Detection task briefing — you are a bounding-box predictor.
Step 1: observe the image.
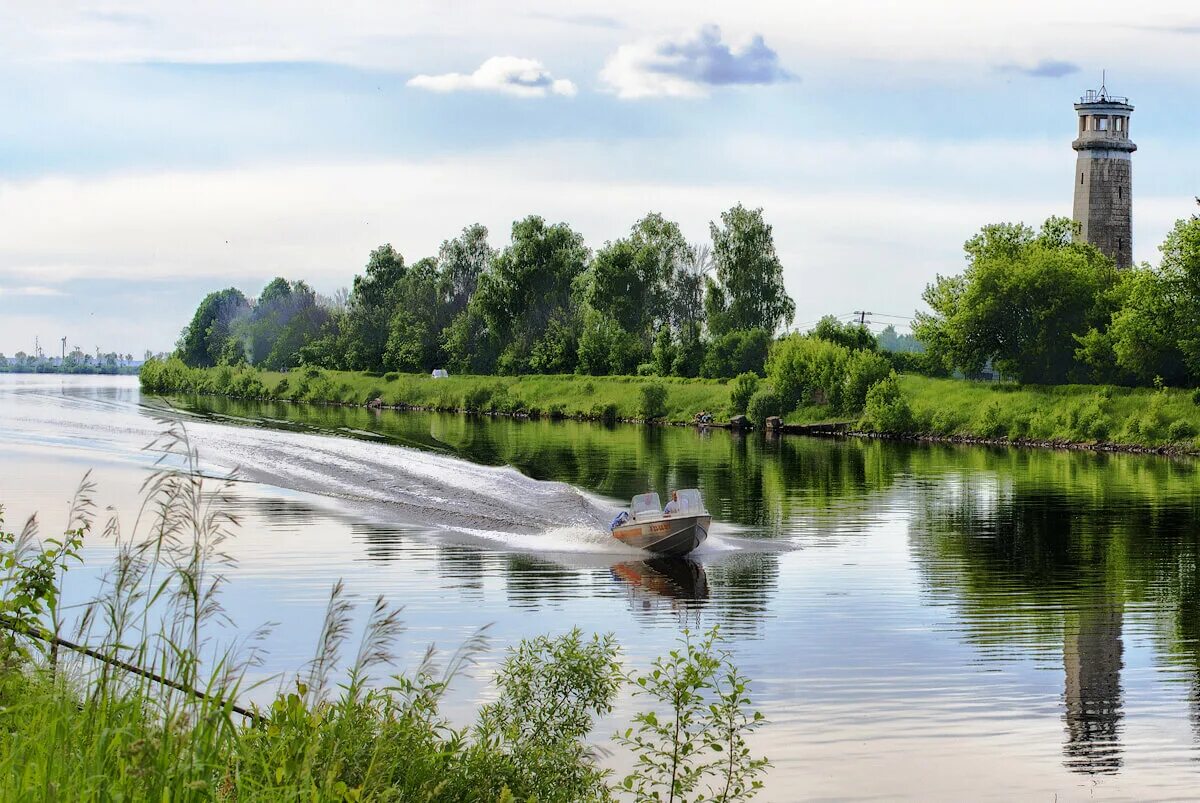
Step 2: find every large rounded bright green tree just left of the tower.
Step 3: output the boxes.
[913,218,1118,383]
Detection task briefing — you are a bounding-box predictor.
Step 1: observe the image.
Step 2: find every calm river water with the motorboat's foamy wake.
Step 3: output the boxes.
[0,374,1200,801]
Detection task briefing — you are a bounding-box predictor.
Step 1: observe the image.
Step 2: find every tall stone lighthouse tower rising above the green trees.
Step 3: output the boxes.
[1072,82,1138,268]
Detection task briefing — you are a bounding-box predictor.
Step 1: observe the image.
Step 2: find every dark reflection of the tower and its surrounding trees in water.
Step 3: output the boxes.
[910,453,1200,774]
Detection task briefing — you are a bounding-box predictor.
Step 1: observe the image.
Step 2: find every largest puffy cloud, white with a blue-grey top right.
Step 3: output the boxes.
[600,25,790,98]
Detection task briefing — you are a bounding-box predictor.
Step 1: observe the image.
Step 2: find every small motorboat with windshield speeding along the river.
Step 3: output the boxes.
[612,489,713,557]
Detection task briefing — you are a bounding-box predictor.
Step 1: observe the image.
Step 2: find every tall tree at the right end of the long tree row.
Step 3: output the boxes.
[707,204,796,335]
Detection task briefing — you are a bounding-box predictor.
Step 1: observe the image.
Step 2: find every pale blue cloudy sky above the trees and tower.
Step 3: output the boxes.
[0,0,1200,355]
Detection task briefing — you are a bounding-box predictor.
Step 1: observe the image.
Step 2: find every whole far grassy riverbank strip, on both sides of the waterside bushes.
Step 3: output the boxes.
[140,360,1200,454]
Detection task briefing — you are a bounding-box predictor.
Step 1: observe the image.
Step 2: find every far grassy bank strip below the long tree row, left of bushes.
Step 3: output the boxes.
[140,360,730,421]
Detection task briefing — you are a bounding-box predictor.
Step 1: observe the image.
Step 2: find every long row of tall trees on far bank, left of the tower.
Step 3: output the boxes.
[176,204,796,377]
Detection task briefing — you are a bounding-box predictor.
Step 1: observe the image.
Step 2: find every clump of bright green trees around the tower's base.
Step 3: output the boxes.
[913,204,1200,386]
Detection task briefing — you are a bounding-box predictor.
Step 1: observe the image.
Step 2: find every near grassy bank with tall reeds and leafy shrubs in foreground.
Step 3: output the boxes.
[0,429,768,803]
